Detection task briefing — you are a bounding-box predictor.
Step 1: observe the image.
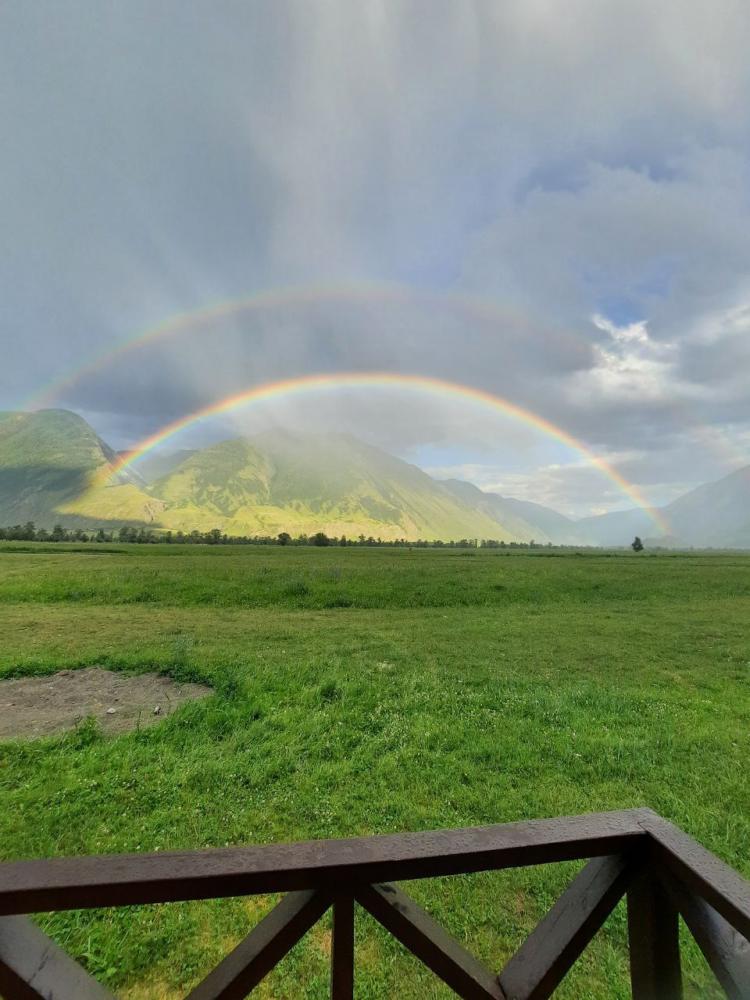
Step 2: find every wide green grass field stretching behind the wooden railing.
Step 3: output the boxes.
[0,544,750,1000]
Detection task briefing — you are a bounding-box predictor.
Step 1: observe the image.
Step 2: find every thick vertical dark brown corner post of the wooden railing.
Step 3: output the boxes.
[628,866,682,1000]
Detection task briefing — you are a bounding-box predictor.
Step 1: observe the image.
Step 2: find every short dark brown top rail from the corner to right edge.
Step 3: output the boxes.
[641,813,750,940]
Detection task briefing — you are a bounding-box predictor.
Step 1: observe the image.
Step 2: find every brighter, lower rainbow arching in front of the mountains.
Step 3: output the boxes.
[102,372,670,534]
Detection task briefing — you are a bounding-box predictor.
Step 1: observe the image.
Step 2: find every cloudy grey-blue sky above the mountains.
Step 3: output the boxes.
[0,0,750,516]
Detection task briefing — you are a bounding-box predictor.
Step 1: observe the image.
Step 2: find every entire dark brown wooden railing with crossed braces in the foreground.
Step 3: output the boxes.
[0,809,750,1000]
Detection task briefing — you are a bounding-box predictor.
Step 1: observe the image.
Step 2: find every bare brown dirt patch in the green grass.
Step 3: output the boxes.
[0,667,212,740]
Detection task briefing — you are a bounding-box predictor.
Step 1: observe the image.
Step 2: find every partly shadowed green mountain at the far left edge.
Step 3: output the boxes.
[0,410,160,527]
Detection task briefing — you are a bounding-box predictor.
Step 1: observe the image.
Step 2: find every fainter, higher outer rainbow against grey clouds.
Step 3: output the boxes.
[20,282,586,410]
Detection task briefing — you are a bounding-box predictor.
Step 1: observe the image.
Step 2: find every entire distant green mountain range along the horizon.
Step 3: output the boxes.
[0,410,750,548]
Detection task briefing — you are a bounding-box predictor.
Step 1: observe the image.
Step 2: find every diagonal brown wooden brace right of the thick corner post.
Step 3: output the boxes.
[659,871,750,1000]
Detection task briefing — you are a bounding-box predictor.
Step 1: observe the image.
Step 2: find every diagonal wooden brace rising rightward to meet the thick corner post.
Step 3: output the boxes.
[498,855,640,1000]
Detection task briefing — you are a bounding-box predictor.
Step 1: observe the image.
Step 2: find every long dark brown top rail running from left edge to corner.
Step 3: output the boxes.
[0,809,652,914]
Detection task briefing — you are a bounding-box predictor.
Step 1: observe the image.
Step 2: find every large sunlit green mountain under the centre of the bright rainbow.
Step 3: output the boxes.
[151,431,519,541]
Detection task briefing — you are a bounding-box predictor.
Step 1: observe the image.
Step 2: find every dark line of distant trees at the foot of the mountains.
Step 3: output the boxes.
[0,521,564,549]
